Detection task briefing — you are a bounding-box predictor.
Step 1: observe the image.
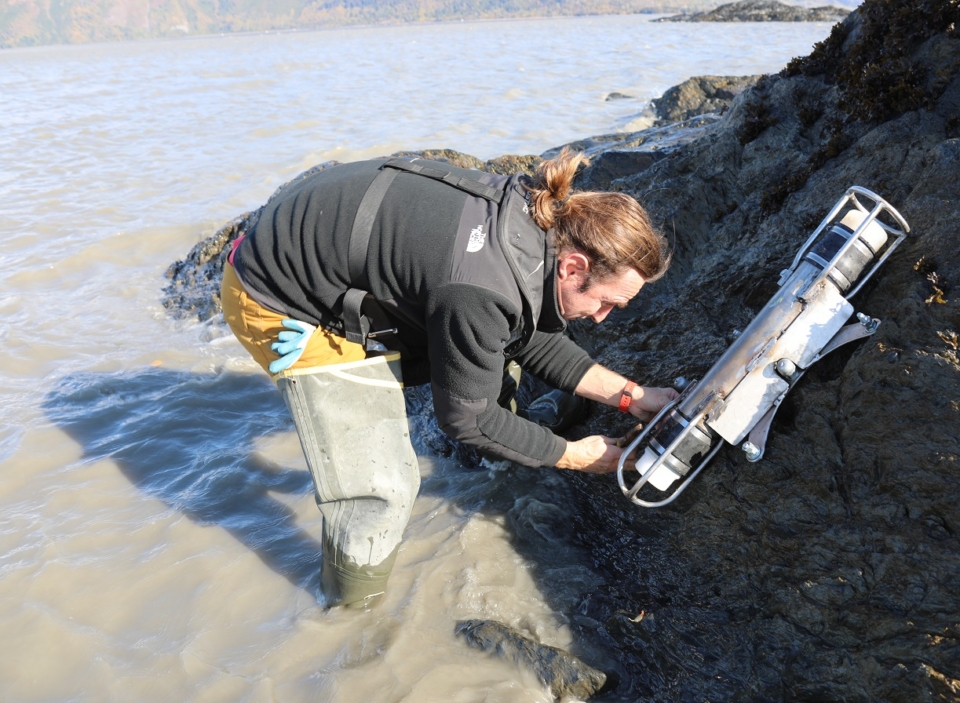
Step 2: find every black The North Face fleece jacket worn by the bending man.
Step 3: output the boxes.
[234,160,594,466]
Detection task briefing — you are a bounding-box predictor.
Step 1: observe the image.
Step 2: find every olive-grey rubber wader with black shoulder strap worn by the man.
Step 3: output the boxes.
[274,160,503,606]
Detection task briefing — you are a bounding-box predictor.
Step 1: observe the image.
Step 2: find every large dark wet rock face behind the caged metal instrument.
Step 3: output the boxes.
[169,0,960,701]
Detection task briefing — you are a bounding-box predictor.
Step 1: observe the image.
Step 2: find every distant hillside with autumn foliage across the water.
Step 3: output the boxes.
[0,0,717,48]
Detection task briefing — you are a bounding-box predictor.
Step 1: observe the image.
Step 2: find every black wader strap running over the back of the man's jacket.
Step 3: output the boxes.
[343,159,504,345]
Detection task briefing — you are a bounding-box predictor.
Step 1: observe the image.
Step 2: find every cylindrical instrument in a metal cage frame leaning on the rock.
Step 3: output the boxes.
[617,186,910,508]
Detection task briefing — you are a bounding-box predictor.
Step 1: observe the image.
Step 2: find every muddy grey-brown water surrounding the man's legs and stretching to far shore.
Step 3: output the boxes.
[0,17,829,703]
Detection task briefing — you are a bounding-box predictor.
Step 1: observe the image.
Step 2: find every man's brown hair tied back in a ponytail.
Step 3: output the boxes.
[527,147,670,281]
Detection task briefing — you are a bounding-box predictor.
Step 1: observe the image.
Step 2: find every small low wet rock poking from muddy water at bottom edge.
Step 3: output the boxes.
[456,620,607,700]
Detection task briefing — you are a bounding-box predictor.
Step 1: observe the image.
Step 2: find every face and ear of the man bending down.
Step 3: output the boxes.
[557,252,644,322]
